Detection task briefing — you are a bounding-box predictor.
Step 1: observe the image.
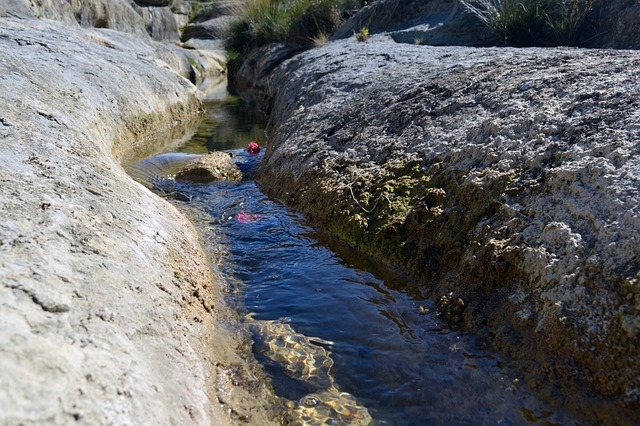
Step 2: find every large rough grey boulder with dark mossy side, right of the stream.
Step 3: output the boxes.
[258,35,640,423]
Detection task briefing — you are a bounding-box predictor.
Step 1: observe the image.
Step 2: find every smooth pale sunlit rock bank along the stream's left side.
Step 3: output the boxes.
[0,18,274,425]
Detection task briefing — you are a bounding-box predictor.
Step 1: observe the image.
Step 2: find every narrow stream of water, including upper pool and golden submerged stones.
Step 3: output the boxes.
[130,97,576,425]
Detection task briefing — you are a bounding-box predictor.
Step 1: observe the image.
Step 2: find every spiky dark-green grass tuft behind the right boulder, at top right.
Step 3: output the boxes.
[459,0,599,46]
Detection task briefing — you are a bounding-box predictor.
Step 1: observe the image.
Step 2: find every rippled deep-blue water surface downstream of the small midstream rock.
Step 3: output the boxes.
[176,175,572,425]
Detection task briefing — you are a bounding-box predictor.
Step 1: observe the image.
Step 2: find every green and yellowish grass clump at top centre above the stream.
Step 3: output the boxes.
[225,0,364,56]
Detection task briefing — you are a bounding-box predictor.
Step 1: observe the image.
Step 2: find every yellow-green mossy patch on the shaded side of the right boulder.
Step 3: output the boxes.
[320,160,521,292]
